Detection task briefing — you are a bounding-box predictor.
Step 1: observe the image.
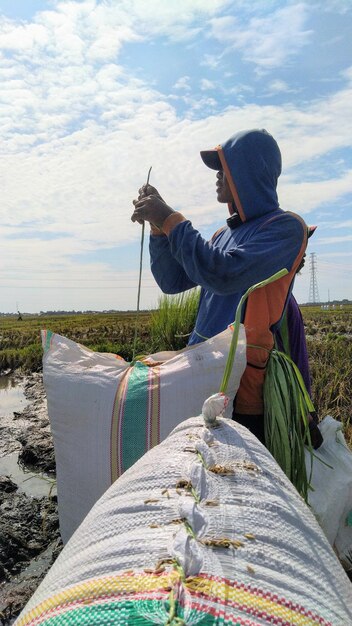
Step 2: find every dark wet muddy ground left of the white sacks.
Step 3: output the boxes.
[0,373,62,626]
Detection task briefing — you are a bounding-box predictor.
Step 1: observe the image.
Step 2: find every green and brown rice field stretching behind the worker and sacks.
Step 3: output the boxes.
[0,299,352,443]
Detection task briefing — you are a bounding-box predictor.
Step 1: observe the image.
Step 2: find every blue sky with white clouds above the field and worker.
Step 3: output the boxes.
[0,0,352,313]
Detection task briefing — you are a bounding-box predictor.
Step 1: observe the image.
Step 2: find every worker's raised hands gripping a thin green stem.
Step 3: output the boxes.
[131,185,174,228]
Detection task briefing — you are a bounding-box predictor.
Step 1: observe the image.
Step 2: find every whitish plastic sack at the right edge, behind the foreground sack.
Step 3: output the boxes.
[306,415,352,569]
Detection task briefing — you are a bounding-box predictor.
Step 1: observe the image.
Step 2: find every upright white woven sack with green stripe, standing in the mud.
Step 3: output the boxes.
[42,326,246,542]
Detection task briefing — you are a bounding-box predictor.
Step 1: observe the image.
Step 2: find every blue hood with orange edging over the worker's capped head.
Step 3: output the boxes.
[201,129,281,222]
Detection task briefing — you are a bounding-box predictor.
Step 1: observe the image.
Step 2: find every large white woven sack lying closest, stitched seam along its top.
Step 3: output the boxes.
[16,400,352,626]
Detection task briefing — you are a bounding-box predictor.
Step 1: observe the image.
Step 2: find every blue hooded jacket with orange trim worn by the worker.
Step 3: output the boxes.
[150,129,307,345]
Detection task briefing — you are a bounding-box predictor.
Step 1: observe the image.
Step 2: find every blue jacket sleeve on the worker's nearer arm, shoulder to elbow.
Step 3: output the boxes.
[168,213,305,295]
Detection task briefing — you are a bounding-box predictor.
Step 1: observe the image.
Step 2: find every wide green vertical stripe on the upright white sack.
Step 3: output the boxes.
[121,361,149,471]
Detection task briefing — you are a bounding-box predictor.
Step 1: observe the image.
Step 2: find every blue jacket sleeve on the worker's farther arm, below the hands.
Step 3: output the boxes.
[149,235,198,294]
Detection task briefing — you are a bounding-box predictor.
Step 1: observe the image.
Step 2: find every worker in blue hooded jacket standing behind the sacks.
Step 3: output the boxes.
[131,129,320,442]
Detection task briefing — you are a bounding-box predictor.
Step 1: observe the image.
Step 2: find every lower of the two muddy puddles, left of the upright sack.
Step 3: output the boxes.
[0,452,57,498]
